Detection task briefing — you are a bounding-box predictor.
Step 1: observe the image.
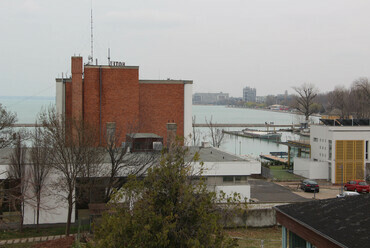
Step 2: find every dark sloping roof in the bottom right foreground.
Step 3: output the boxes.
[275,194,370,247]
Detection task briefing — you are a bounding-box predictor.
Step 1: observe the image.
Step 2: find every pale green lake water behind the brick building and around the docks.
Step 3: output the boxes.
[0,96,317,157]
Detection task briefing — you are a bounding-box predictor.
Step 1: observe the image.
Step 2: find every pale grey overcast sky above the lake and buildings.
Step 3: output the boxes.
[0,0,370,96]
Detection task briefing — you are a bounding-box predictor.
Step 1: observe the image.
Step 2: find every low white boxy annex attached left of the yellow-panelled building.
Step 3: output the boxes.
[293,158,329,179]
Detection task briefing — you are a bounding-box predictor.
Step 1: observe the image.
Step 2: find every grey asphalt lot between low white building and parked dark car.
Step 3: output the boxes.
[248,179,310,203]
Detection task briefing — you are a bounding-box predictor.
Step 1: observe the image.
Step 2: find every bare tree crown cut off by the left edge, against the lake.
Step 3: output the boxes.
[0,104,17,149]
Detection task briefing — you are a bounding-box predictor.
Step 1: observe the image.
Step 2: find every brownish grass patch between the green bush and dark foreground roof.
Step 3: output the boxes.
[226,227,281,248]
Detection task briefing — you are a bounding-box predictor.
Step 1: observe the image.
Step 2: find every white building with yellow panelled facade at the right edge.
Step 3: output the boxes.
[294,119,370,183]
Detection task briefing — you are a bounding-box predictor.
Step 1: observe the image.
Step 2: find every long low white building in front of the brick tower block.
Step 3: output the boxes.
[0,146,261,225]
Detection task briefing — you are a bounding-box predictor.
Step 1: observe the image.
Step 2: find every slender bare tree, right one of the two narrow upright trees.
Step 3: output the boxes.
[30,126,51,232]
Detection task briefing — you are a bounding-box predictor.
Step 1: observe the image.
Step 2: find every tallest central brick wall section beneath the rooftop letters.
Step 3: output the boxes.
[84,66,139,143]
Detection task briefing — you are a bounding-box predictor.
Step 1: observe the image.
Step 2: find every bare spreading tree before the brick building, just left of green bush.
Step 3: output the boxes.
[104,123,159,202]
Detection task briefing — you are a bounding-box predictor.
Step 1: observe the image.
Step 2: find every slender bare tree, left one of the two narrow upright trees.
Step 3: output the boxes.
[8,131,29,231]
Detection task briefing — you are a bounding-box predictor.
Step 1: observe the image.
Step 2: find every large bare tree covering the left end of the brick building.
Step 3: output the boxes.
[39,108,103,236]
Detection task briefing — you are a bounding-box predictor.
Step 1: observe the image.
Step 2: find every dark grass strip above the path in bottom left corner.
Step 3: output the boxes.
[0,225,89,240]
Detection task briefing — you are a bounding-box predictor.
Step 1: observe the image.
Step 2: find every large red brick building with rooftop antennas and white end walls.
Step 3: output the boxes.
[56,57,193,145]
